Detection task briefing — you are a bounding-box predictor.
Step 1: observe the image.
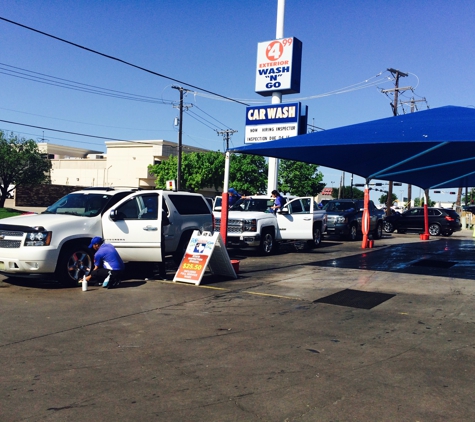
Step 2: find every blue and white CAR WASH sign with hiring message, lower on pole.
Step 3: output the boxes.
[244,103,301,144]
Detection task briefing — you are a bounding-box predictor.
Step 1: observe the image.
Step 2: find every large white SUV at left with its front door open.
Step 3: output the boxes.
[0,188,213,284]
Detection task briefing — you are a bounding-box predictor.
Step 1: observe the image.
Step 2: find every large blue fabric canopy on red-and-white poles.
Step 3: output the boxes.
[230,106,475,189]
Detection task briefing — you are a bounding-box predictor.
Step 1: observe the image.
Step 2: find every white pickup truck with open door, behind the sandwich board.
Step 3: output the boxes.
[214,195,327,255]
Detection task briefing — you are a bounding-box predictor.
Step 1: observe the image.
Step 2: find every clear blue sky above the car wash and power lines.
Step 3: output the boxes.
[0,0,475,200]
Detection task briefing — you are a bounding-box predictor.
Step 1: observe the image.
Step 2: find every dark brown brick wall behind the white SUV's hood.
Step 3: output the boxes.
[15,185,84,207]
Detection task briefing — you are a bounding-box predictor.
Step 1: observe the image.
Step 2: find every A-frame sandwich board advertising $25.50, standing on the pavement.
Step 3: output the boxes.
[173,230,237,286]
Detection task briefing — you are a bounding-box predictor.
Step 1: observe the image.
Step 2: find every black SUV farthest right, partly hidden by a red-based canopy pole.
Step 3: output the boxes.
[384,207,462,236]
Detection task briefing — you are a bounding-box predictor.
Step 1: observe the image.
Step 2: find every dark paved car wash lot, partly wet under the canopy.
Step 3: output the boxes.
[0,230,475,422]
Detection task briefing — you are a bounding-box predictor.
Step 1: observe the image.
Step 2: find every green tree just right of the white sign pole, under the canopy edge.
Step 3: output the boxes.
[278,160,325,196]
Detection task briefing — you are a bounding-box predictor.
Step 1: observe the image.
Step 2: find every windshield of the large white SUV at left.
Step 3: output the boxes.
[44,193,111,217]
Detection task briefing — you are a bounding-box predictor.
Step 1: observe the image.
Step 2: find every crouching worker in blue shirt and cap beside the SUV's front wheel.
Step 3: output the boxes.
[86,236,125,289]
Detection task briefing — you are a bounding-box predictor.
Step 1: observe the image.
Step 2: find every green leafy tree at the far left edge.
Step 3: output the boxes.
[0,130,51,208]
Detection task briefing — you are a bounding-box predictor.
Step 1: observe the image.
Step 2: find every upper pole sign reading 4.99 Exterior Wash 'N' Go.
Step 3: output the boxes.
[256,38,302,97]
